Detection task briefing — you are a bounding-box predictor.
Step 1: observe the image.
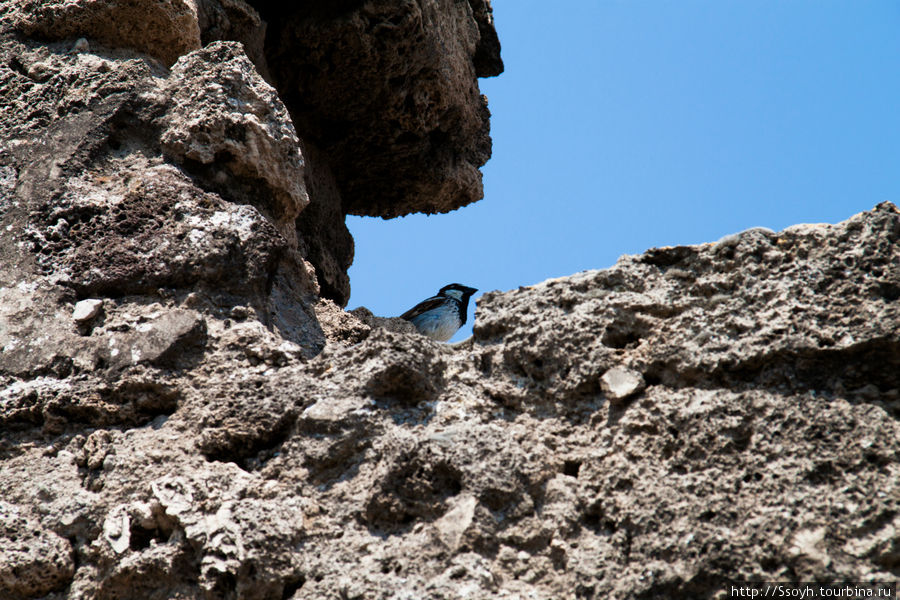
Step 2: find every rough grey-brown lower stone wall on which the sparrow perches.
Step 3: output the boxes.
[0,198,900,599]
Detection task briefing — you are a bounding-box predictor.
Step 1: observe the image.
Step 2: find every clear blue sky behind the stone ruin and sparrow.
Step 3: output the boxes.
[347,0,900,341]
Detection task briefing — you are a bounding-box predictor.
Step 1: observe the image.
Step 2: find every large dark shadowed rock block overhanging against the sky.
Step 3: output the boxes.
[260,0,503,218]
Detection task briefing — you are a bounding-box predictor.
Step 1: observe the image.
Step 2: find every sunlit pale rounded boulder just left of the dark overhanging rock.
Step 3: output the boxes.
[160,42,312,244]
